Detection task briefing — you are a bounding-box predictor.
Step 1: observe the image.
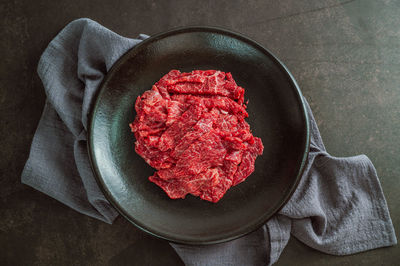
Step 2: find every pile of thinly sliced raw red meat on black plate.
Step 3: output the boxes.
[130,70,264,202]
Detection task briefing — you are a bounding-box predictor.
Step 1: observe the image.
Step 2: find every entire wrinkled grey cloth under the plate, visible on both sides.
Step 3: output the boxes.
[22,19,397,265]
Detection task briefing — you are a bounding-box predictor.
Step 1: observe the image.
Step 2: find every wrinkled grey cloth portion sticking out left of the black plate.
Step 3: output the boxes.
[22,19,146,223]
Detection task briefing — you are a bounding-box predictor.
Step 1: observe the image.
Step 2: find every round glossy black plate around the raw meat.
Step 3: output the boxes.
[88,27,309,244]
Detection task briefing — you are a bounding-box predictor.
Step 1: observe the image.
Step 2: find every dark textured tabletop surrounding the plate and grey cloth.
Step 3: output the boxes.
[0,0,400,265]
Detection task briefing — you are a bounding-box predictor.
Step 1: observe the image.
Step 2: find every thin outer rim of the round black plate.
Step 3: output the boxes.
[87,26,310,245]
